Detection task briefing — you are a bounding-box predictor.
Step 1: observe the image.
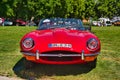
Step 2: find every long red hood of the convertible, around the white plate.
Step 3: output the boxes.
[22,28,99,53]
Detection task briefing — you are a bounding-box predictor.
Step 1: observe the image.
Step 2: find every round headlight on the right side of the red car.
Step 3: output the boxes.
[87,38,98,51]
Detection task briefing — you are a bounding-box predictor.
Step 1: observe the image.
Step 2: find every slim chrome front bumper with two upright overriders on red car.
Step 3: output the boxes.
[21,50,100,60]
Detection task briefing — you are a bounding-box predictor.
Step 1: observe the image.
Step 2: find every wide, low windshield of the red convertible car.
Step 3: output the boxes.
[38,18,84,30]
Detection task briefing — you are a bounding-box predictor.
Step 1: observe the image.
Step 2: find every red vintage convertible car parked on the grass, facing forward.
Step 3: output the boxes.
[20,18,100,67]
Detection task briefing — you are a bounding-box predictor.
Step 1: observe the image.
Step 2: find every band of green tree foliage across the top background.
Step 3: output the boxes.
[0,0,120,20]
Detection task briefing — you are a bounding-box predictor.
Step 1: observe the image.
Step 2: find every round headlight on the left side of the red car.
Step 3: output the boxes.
[22,38,34,49]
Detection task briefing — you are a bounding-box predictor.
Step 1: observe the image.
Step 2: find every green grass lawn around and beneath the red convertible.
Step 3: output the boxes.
[0,26,120,80]
